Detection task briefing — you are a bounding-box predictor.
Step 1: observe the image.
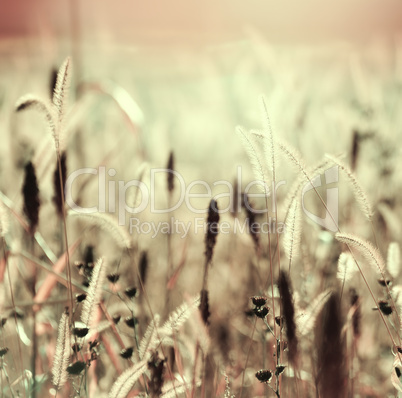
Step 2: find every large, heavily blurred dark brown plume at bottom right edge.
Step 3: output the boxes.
[316,293,347,398]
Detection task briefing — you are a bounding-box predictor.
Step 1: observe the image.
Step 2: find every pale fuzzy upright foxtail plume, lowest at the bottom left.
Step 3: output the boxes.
[52,309,70,390]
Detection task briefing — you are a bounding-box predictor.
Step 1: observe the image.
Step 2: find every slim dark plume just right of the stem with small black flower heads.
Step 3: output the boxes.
[278,271,298,364]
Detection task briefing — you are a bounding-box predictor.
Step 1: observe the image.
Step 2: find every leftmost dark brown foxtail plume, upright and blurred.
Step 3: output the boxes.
[22,162,40,234]
